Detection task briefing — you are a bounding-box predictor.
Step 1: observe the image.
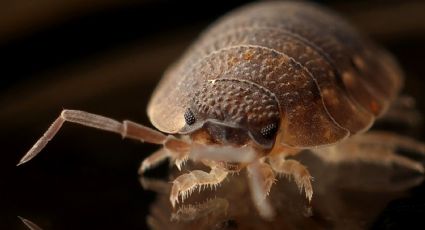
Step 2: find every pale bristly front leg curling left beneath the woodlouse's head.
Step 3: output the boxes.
[170,167,228,207]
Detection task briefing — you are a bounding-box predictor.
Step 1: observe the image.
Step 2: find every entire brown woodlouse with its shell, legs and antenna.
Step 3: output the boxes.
[20,2,423,217]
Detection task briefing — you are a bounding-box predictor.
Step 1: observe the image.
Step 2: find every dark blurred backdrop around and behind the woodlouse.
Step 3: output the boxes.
[0,0,425,229]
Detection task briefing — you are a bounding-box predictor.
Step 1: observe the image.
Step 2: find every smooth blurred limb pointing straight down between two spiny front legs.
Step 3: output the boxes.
[247,161,275,219]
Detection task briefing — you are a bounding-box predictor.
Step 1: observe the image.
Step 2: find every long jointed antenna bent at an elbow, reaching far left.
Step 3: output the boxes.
[18,109,184,165]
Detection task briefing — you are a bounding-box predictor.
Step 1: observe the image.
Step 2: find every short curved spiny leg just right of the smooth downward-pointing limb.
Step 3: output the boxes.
[269,154,313,201]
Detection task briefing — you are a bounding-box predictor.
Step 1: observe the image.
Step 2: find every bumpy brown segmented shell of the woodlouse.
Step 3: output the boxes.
[148,2,402,148]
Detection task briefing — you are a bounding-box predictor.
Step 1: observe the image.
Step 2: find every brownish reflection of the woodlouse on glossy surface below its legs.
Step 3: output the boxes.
[147,151,423,230]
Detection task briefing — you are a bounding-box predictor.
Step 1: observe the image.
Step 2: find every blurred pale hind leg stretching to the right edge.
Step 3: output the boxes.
[312,131,425,173]
